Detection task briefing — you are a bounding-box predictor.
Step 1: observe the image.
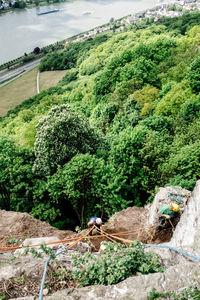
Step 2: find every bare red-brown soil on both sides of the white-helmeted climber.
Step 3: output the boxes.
[0,207,172,250]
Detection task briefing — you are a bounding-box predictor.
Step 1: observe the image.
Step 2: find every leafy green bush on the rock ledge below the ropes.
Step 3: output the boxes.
[72,241,163,286]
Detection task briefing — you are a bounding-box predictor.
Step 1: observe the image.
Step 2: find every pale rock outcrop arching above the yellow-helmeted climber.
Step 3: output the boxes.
[148,186,191,225]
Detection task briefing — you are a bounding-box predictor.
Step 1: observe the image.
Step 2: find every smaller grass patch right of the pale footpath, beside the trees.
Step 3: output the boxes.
[40,70,66,91]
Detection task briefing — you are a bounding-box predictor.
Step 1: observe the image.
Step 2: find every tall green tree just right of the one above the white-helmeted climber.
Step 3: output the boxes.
[108,126,148,206]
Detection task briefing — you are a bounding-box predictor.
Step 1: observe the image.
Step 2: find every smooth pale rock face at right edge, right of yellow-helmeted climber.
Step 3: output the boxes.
[170,180,200,250]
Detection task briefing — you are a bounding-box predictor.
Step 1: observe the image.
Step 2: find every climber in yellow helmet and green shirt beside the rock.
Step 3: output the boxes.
[157,203,182,231]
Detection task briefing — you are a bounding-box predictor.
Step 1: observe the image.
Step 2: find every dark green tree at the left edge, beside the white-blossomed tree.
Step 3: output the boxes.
[0,136,36,211]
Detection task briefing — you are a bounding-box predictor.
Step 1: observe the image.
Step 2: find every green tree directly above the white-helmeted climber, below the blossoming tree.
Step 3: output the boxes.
[48,153,108,228]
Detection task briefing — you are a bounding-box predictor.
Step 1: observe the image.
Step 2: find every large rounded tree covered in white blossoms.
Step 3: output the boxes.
[33,104,104,175]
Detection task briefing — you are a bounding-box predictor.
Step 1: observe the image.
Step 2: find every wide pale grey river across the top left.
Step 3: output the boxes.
[0,0,169,64]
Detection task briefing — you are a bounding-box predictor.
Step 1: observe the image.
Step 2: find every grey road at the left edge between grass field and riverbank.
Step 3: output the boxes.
[0,58,41,86]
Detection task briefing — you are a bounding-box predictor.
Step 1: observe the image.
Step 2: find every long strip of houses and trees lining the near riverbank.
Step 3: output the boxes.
[0,0,200,70]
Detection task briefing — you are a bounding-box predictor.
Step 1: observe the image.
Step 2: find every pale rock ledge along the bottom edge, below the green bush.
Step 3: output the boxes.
[41,263,200,300]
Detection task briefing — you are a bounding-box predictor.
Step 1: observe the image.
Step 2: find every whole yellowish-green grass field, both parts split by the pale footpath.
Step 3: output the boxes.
[0,68,66,117]
